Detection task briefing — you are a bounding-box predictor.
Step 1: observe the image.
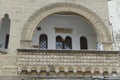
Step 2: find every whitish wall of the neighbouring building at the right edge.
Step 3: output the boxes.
[108,0,120,50]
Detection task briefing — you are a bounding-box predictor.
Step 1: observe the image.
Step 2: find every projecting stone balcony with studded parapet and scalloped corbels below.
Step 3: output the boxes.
[17,49,120,76]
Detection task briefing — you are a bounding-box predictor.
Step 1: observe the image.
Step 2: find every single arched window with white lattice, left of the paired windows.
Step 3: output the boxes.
[39,34,48,49]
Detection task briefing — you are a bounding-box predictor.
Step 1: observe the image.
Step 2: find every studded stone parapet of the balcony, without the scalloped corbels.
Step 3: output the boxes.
[17,50,120,76]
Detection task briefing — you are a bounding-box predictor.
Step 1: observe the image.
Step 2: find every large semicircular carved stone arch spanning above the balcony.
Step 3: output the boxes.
[21,2,112,50]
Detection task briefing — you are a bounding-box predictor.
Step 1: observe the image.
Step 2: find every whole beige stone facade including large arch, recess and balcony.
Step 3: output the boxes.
[0,0,120,77]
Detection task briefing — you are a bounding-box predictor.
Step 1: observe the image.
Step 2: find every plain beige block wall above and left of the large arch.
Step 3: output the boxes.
[0,0,111,76]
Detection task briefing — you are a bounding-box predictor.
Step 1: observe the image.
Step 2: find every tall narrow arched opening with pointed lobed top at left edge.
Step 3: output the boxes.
[0,13,10,49]
